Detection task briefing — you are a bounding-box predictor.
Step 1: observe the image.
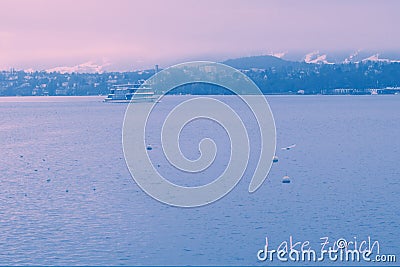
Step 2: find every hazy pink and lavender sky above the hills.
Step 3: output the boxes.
[0,0,400,69]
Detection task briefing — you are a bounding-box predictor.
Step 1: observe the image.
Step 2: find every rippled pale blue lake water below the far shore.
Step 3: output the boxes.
[0,96,400,265]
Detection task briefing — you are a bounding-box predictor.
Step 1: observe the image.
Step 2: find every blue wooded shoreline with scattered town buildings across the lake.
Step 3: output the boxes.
[0,56,400,96]
